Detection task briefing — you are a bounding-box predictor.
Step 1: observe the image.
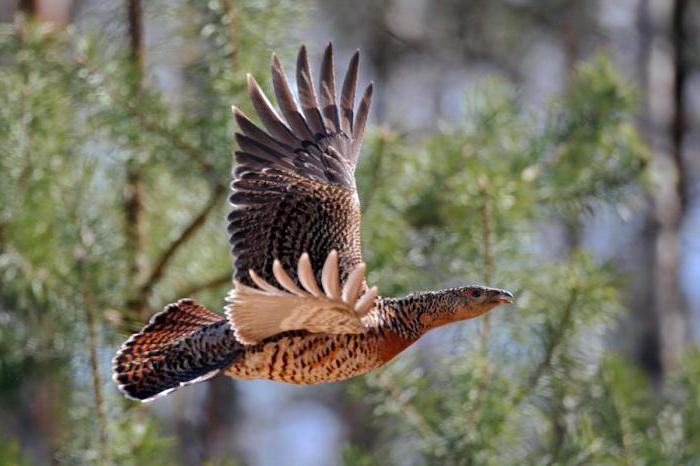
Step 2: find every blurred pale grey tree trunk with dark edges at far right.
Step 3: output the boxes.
[640,0,689,375]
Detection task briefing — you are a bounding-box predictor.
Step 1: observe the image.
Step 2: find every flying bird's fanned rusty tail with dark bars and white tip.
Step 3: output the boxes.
[112,299,241,401]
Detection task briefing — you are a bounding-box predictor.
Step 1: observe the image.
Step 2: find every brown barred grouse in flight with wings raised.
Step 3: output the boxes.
[112,43,513,401]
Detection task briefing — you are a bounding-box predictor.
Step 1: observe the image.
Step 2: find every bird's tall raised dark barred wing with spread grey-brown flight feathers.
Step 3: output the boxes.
[228,44,372,289]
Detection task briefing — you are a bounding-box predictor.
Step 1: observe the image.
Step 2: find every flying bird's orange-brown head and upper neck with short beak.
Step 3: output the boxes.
[419,285,513,329]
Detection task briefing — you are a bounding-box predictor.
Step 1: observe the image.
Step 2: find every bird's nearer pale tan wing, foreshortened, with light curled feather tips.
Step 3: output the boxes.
[226,250,377,344]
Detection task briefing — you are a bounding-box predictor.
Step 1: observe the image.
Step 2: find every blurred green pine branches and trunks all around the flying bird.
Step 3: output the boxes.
[0,0,700,465]
